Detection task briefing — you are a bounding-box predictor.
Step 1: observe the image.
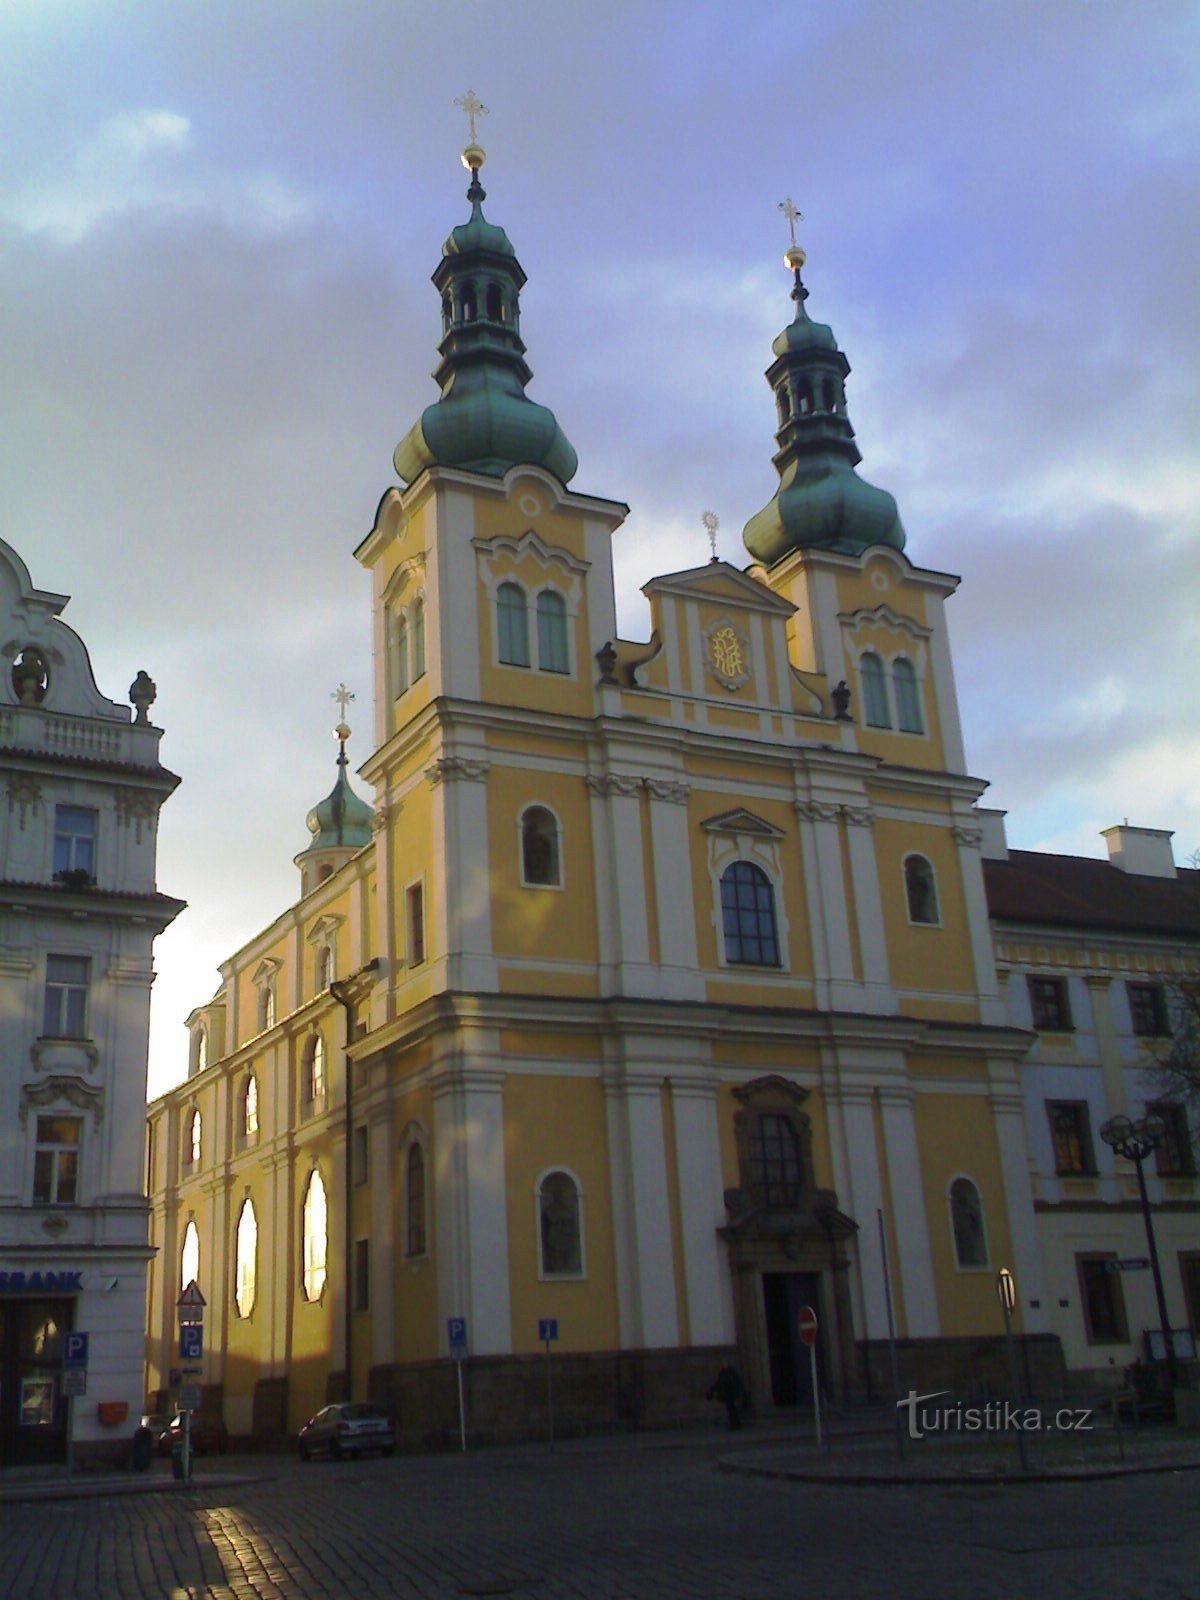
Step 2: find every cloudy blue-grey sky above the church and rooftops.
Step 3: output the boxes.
[0,0,1200,1093]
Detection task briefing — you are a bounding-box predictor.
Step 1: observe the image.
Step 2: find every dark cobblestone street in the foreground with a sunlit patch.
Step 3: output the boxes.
[0,1437,1200,1600]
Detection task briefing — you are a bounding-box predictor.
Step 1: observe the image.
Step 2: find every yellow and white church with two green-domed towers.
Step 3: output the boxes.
[147,139,1177,1443]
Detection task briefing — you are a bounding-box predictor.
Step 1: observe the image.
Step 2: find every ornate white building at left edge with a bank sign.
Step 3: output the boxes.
[0,541,182,1466]
